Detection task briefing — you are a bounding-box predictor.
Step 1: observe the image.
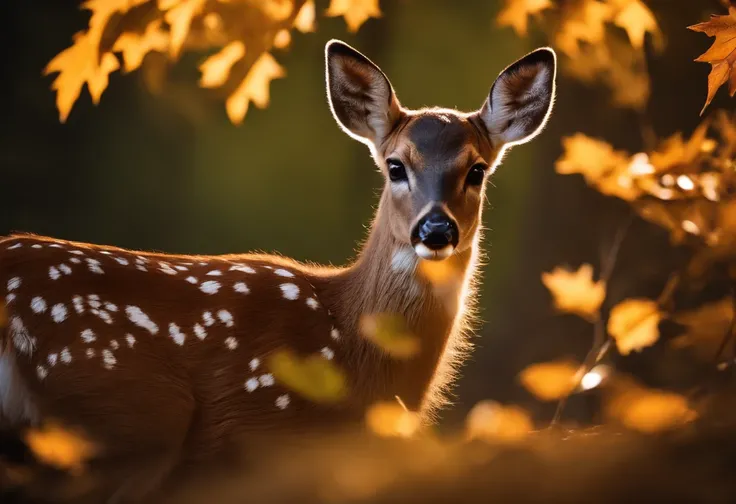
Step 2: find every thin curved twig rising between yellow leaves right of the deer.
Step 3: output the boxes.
[550,217,634,427]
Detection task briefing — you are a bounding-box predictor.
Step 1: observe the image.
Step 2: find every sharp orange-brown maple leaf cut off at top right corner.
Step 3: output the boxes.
[688,7,736,115]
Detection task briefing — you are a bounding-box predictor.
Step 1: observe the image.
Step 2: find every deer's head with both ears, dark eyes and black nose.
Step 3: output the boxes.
[326,40,556,260]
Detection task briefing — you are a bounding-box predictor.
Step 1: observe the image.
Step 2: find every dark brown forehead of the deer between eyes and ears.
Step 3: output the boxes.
[386,110,489,173]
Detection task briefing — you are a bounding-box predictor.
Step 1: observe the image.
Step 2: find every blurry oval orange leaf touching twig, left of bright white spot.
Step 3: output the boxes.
[519,361,581,401]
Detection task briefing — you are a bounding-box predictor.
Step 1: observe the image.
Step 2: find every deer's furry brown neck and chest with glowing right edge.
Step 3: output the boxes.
[320,193,479,412]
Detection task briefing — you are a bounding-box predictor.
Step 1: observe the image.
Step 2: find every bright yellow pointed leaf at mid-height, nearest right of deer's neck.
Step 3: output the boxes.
[542,264,606,319]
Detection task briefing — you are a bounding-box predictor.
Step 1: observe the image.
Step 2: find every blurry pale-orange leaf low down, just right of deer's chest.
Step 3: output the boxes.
[465,401,534,443]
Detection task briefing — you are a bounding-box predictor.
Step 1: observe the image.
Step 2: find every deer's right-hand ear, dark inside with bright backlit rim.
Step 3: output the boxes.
[479,48,557,146]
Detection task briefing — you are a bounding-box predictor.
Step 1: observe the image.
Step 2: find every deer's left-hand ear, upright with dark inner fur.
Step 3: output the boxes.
[325,40,401,146]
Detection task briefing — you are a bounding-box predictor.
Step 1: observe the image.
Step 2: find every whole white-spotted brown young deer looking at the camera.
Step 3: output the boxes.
[0,40,556,502]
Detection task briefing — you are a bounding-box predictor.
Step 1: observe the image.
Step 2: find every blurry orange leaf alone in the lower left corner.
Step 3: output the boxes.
[25,424,95,470]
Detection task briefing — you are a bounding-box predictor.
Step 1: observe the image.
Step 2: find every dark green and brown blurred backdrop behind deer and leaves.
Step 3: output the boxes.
[0,0,732,425]
